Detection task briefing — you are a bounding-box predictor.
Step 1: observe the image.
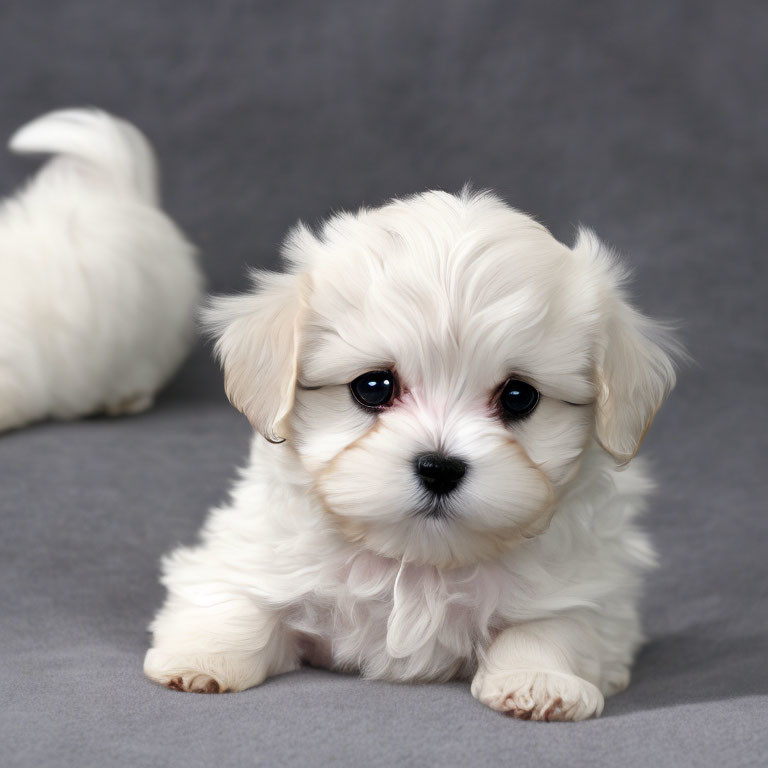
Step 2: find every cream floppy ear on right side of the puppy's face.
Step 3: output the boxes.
[573,229,681,466]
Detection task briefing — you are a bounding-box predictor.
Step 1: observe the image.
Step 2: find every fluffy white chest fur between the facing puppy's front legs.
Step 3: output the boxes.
[286,556,495,680]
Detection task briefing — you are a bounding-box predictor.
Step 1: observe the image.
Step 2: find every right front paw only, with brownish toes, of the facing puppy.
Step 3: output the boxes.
[472,667,604,720]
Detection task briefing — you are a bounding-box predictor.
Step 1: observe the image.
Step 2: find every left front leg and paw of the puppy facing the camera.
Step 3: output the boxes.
[144,569,299,693]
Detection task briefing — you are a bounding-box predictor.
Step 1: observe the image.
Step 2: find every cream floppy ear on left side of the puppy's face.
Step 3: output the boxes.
[203,272,307,443]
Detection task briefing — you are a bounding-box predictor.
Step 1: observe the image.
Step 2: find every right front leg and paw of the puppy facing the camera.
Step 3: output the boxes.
[472,618,603,720]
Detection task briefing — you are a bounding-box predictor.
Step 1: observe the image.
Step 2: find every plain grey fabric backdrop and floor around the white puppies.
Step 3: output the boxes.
[0,0,768,767]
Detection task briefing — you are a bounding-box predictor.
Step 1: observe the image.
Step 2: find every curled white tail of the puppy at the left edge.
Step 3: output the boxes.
[8,109,159,204]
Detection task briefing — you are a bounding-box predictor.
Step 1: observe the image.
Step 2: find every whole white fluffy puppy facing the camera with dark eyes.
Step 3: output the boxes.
[145,192,674,720]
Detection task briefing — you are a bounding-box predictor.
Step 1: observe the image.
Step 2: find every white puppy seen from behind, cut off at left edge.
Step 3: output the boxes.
[0,109,202,431]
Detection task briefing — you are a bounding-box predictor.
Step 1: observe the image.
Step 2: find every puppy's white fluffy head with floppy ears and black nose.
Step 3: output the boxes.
[208,192,674,567]
